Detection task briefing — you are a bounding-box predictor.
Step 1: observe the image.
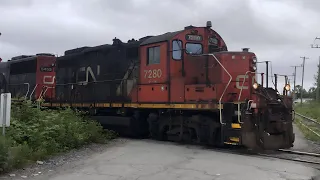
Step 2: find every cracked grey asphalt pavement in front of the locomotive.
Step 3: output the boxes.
[17,140,319,180]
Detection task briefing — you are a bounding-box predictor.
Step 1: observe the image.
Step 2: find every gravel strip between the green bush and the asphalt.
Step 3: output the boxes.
[0,139,127,180]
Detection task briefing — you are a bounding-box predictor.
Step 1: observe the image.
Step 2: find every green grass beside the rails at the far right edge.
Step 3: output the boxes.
[295,101,320,143]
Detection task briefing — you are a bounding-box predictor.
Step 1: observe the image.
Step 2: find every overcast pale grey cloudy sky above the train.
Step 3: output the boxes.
[0,0,320,88]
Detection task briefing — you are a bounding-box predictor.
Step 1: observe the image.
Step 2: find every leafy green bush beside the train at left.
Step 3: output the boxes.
[0,103,115,173]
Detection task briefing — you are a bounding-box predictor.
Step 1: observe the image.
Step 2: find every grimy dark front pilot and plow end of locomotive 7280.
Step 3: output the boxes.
[242,88,295,150]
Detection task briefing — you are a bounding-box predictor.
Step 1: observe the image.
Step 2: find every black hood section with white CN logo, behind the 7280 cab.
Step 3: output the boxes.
[55,38,142,103]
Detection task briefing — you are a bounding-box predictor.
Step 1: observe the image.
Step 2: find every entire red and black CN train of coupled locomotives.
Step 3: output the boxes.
[0,21,294,150]
